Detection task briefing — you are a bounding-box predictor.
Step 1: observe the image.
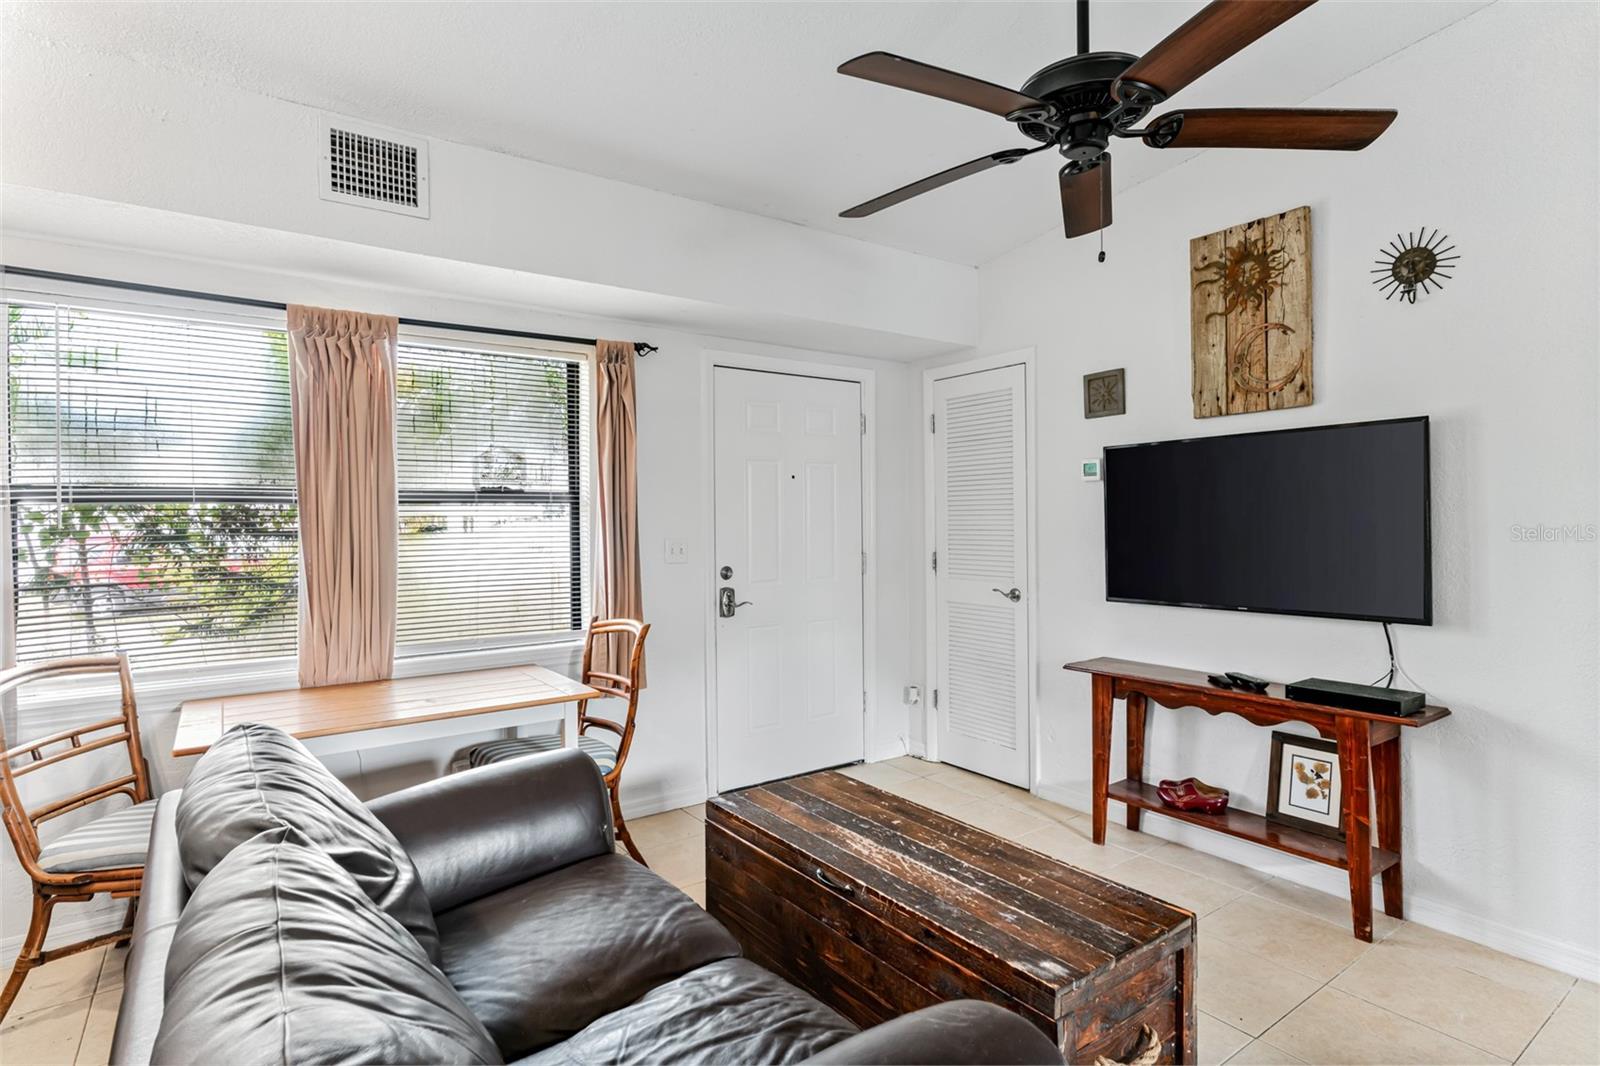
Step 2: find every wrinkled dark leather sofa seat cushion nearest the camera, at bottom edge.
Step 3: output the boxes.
[518,959,856,1066]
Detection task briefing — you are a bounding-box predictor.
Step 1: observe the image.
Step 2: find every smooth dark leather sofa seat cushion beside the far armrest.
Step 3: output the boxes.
[438,855,739,1058]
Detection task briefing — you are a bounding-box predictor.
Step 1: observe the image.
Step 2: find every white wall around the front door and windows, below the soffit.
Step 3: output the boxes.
[0,235,918,951]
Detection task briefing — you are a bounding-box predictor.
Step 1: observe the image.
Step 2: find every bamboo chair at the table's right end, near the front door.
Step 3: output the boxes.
[467,618,650,866]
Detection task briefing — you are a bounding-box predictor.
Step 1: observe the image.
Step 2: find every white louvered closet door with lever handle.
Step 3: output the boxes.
[933,367,1030,787]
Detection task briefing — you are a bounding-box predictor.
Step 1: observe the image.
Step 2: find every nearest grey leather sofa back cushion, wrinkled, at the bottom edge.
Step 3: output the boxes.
[150,826,501,1063]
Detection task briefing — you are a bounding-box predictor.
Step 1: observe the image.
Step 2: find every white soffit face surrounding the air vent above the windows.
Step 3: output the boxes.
[0,30,978,355]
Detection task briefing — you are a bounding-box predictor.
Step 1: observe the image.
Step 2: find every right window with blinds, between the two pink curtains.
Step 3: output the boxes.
[395,339,587,656]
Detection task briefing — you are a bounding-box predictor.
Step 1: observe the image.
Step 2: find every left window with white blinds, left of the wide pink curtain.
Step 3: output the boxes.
[5,303,298,667]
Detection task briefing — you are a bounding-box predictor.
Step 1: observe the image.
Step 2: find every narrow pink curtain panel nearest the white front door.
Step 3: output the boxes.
[592,341,645,687]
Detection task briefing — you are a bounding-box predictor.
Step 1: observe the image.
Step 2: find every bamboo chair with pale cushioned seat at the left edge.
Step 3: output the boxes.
[0,655,155,1020]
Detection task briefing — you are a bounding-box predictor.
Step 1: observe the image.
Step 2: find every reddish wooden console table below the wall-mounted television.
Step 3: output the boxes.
[1066,659,1450,941]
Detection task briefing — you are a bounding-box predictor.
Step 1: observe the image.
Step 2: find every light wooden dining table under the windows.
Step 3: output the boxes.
[173,666,600,757]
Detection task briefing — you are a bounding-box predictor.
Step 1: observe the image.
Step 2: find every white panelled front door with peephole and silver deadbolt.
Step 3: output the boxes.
[712,367,866,791]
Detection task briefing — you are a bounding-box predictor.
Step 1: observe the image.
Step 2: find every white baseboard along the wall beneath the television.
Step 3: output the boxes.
[1035,784,1600,981]
